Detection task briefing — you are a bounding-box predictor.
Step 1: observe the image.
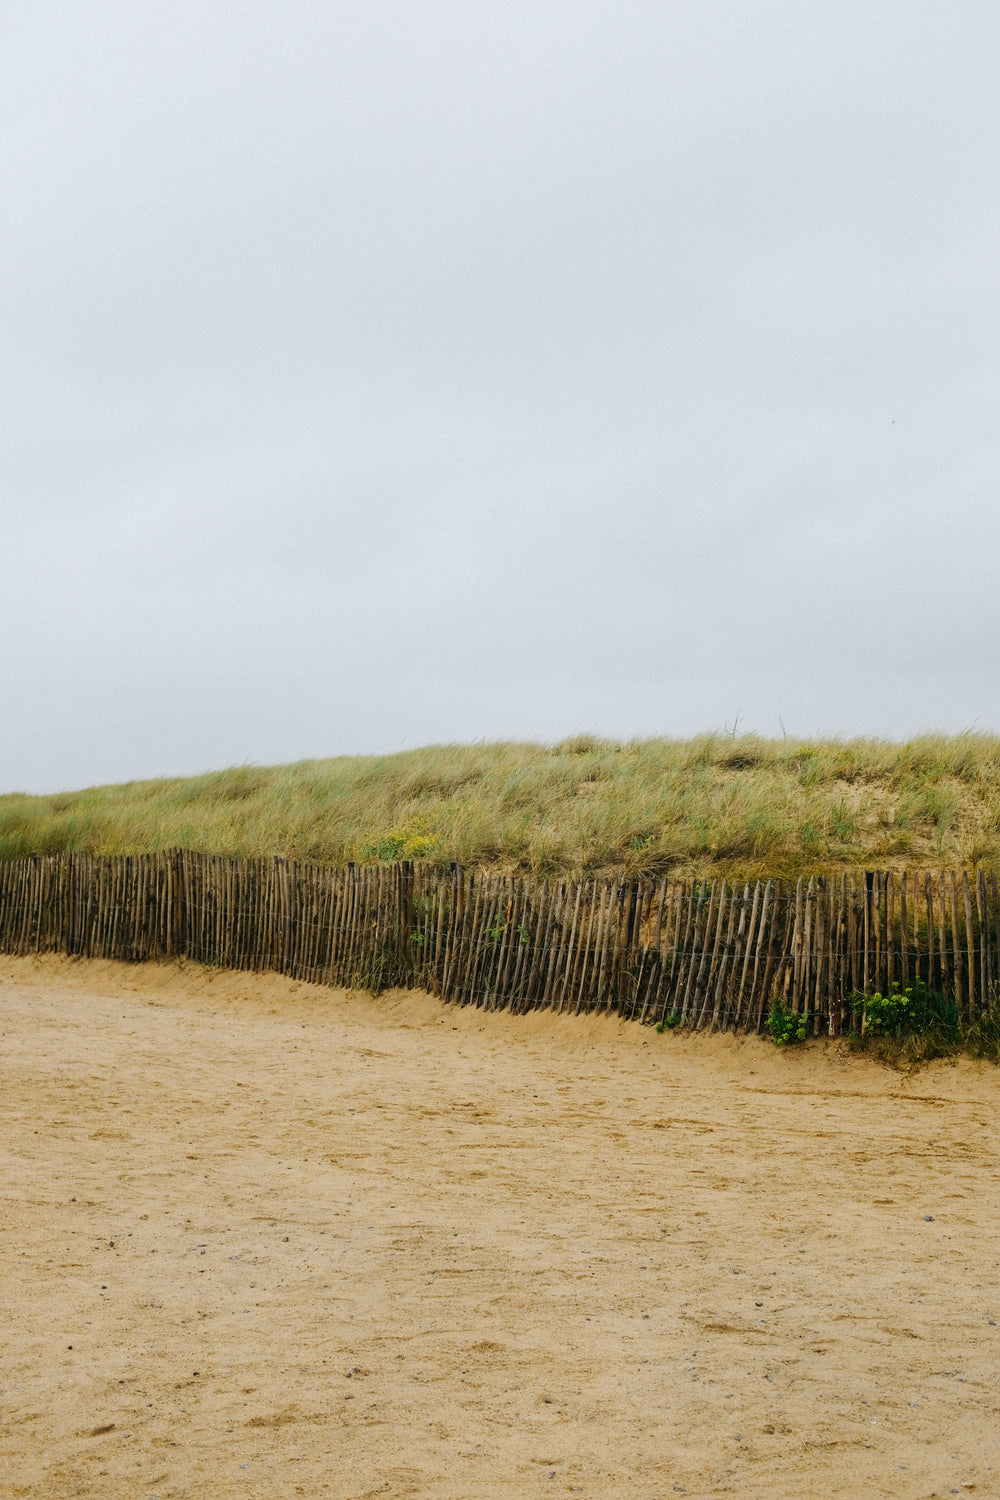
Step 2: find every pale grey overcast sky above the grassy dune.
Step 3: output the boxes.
[0,0,1000,791]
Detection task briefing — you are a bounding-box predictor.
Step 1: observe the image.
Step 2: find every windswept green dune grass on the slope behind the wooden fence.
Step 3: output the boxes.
[0,735,1000,876]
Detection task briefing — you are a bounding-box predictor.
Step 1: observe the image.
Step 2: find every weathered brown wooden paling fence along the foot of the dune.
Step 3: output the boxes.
[0,851,1000,1037]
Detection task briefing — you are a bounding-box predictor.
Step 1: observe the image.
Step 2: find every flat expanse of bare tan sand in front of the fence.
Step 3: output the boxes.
[0,959,1000,1500]
